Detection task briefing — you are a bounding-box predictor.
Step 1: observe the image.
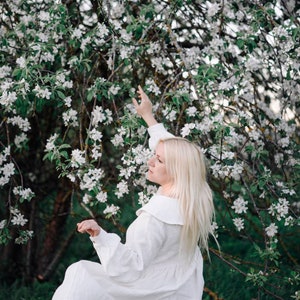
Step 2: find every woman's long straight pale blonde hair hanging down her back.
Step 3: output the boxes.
[161,137,214,256]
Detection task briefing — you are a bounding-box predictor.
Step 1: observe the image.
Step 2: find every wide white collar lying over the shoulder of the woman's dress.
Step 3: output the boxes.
[136,194,184,225]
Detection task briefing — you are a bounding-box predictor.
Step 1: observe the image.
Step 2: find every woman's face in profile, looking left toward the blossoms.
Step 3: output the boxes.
[147,142,173,188]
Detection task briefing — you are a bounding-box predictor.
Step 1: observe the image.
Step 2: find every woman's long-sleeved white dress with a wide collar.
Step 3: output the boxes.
[52,124,204,300]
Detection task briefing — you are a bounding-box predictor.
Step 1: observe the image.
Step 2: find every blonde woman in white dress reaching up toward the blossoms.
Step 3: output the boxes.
[53,86,214,300]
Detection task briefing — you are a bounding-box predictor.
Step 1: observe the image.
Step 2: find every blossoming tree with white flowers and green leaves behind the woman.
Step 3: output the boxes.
[0,0,300,299]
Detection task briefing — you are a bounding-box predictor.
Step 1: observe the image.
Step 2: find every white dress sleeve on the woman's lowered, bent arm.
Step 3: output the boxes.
[90,212,165,282]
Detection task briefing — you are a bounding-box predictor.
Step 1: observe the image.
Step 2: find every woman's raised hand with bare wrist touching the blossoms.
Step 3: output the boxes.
[132,85,157,126]
